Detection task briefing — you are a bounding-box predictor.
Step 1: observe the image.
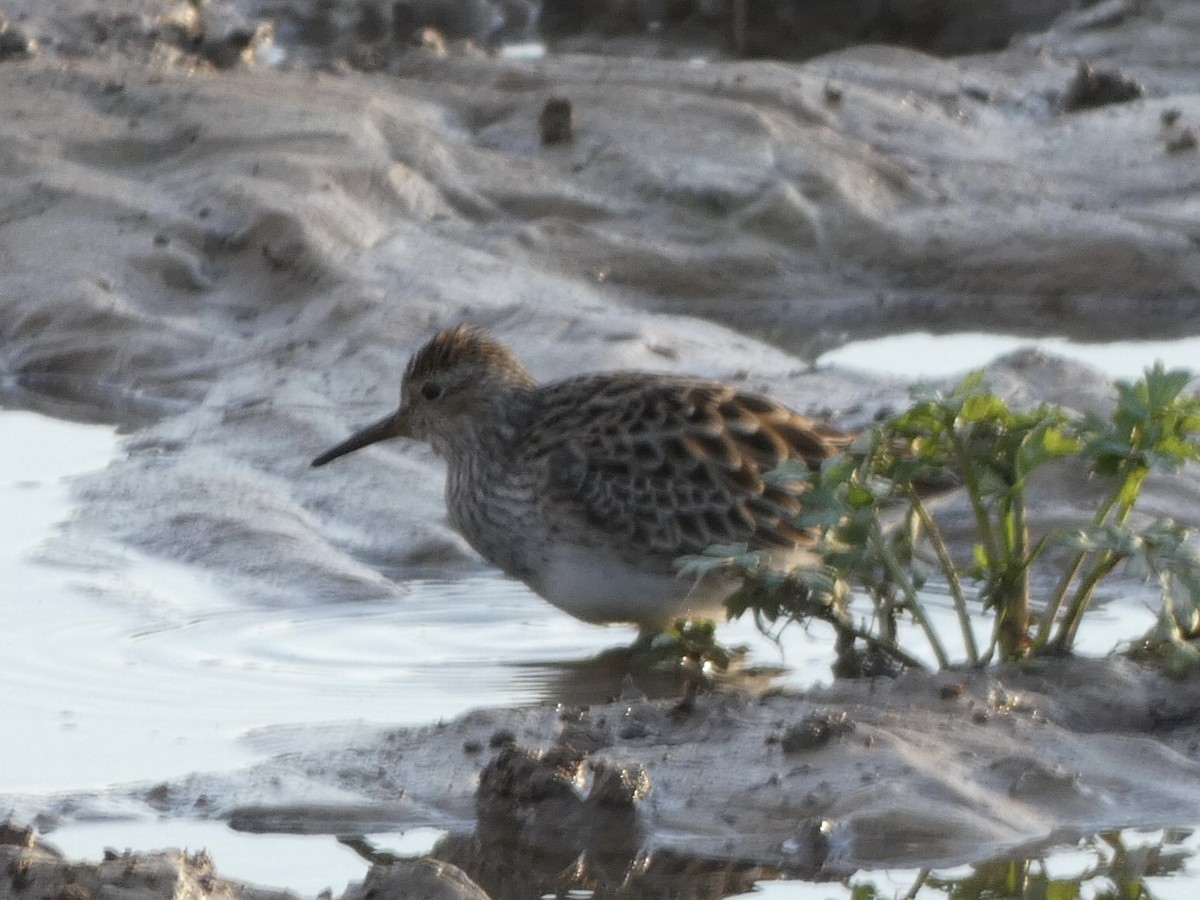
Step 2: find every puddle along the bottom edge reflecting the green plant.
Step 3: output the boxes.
[342,828,1200,900]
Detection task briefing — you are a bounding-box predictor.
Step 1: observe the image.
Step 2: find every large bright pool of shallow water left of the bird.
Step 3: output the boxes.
[0,412,632,792]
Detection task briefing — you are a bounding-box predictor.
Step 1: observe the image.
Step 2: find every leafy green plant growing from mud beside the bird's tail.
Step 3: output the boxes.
[683,365,1200,670]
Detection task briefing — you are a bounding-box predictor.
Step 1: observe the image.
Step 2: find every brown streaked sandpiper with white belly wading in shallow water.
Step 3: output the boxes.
[312,324,854,635]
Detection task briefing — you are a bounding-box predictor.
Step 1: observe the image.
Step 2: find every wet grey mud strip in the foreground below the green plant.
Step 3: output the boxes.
[16,659,1200,896]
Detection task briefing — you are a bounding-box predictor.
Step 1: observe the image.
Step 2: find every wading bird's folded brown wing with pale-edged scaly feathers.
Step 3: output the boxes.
[526,373,852,557]
